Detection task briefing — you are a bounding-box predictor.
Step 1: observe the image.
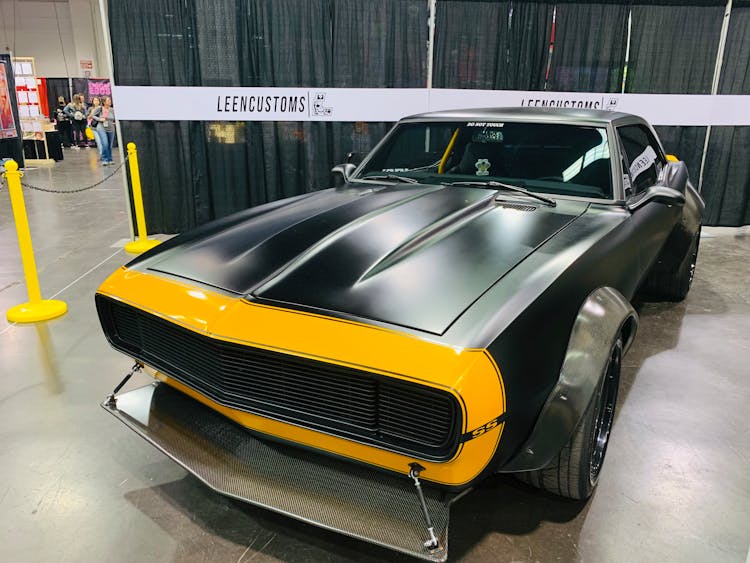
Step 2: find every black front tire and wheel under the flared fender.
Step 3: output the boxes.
[516,338,622,500]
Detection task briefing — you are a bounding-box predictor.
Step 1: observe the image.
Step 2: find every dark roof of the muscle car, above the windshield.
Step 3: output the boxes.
[402,107,633,124]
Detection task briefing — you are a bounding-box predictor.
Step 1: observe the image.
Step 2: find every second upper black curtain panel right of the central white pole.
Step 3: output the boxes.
[547,2,629,92]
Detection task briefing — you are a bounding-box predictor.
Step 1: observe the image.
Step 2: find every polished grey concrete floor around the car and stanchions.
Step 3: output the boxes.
[0,150,750,563]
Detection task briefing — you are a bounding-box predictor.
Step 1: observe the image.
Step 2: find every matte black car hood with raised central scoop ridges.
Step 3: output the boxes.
[141,185,588,334]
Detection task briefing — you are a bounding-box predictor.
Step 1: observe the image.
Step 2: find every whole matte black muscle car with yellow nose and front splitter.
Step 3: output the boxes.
[96,108,703,560]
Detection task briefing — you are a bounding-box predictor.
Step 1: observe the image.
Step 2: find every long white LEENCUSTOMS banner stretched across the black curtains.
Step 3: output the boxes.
[112,86,750,125]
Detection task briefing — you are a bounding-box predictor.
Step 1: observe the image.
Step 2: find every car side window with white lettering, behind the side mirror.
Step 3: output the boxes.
[617,125,665,194]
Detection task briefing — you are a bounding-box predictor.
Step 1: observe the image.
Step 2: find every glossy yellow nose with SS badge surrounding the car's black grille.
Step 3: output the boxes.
[99,268,506,487]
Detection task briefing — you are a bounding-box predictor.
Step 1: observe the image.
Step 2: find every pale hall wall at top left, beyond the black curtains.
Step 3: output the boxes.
[0,0,107,78]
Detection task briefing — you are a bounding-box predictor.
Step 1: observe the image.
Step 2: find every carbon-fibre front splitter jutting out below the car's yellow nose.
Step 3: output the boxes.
[102,383,456,561]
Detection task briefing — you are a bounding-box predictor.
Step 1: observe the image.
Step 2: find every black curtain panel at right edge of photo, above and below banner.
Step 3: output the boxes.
[703,2,750,226]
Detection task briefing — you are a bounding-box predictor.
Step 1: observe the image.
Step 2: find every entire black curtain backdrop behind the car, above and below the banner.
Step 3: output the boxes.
[109,0,750,232]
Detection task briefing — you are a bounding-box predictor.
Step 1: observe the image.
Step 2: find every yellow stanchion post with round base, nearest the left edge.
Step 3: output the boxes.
[3,160,68,323]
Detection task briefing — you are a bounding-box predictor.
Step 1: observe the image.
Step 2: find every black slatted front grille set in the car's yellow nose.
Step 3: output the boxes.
[96,295,461,460]
